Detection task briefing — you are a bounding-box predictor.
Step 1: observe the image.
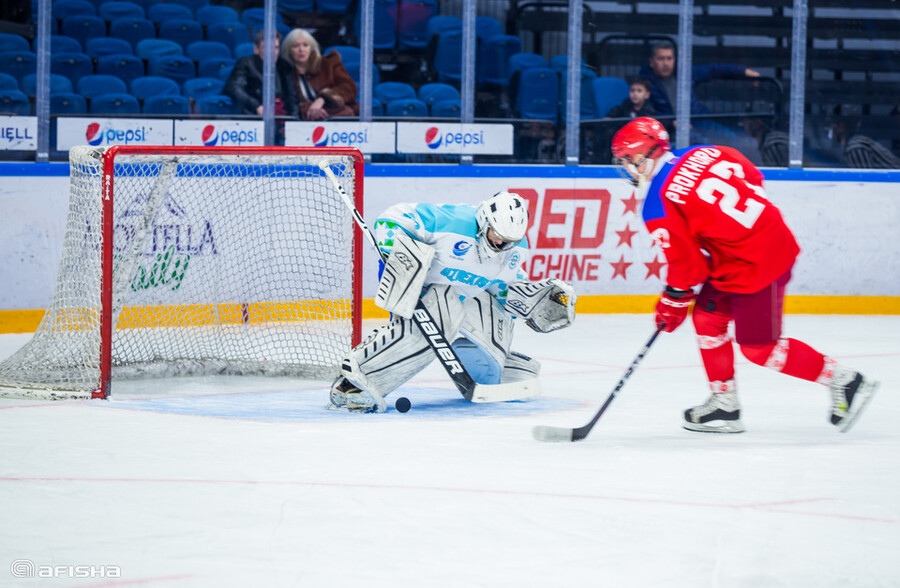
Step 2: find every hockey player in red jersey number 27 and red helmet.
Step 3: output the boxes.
[612,117,878,433]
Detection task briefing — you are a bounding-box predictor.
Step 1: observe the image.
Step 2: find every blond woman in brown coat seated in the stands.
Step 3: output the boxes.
[281,29,359,120]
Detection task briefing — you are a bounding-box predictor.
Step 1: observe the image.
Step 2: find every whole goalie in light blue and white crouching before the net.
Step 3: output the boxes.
[328,192,576,412]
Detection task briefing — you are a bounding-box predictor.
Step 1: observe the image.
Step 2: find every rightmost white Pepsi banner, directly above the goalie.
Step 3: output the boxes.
[397,122,513,155]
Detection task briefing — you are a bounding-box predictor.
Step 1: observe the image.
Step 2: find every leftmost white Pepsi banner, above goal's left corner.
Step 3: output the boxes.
[56,117,172,151]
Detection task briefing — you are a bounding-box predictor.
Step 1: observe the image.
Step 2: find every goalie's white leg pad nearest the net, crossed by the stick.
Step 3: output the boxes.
[341,286,463,402]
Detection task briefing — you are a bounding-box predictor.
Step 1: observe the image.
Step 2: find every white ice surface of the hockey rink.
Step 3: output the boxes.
[0,315,900,588]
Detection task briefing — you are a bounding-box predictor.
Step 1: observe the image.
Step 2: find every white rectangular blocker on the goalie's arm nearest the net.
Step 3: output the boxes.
[375,231,435,319]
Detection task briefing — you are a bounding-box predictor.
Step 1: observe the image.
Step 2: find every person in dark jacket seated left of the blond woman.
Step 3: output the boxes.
[223,31,299,118]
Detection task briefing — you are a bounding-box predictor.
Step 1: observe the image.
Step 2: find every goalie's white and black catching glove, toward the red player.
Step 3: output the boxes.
[506,278,578,333]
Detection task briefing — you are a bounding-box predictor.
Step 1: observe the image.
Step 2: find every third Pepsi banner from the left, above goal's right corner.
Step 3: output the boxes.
[284,122,397,153]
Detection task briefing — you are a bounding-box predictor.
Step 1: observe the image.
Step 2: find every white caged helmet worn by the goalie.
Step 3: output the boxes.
[475,191,528,259]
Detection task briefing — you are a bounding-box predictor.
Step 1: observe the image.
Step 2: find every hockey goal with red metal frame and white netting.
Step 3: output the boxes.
[0,146,363,399]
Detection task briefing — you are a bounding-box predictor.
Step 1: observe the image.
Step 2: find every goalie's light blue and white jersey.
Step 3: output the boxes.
[374,202,528,302]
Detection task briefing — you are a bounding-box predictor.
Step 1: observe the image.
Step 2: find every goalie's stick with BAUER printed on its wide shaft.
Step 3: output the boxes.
[319,159,540,402]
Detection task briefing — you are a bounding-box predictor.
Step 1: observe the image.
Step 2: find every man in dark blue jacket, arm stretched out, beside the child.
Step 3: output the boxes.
[638,41,759,115]
